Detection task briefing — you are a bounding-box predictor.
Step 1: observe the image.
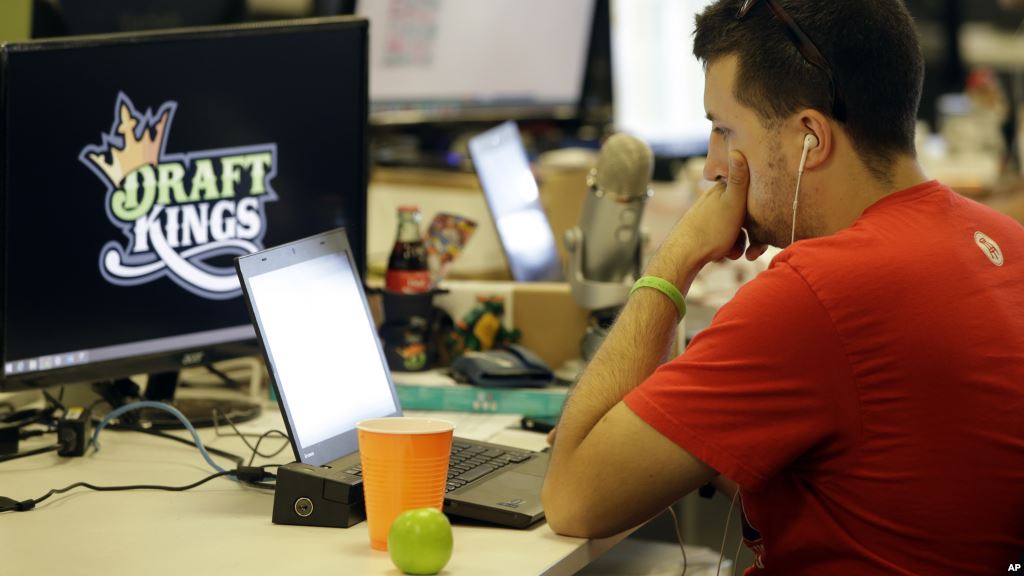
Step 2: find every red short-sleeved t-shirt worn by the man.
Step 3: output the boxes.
[626,181,1024,575]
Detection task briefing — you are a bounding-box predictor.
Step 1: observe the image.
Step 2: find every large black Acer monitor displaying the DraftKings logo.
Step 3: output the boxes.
[0,17,369,409]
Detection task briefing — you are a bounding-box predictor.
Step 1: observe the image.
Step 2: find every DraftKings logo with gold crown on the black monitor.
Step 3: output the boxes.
[79,92,278,299]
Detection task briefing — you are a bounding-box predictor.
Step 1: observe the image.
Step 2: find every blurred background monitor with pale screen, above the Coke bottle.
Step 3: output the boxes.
[356,0,594,124]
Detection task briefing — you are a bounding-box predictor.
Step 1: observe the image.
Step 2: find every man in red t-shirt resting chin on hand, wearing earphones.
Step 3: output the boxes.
[544,0,1024,575]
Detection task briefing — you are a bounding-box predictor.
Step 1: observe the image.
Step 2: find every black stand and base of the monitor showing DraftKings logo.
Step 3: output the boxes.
[100,371,260,429]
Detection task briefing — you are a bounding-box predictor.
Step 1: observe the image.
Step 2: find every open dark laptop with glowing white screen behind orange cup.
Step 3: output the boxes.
[236,229,548,528]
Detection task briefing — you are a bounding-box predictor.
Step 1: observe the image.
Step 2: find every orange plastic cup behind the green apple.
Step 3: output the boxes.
[355,416,455,550]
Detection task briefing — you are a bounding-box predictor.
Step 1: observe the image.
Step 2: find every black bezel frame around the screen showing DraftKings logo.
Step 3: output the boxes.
[0,15,370,392]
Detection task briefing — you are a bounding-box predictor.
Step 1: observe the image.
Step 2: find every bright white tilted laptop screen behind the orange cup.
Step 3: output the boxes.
[239,226,400,465]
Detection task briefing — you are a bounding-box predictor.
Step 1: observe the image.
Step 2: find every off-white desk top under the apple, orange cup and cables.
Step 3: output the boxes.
[0,408,626,576]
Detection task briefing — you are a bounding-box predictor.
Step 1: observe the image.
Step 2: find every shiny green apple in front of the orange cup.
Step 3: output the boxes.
[387,508,452,574]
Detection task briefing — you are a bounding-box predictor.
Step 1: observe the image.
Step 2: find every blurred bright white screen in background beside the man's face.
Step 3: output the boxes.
[610,0,711,158]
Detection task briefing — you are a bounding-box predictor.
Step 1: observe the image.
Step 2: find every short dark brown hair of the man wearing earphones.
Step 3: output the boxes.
[693,0,925,181]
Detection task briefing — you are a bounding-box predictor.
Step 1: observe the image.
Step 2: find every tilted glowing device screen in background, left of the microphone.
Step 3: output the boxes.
[469,120,563,282]
